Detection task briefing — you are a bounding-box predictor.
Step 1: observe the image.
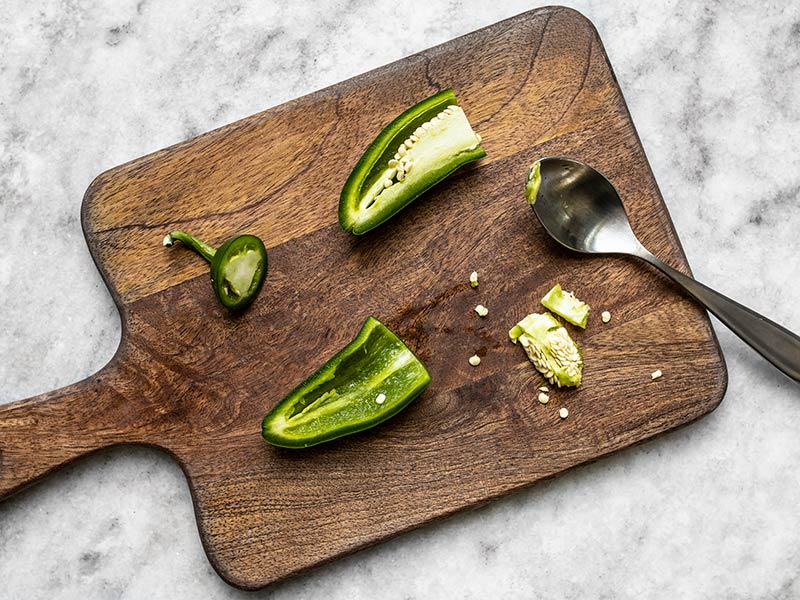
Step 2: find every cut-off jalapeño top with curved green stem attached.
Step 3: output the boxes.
[164,230,267,310]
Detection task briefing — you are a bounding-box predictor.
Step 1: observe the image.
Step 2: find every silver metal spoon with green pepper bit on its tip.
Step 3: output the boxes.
[525,157,800,381]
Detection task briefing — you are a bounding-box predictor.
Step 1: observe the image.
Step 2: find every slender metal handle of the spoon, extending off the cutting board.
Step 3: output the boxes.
[637,249,800,382]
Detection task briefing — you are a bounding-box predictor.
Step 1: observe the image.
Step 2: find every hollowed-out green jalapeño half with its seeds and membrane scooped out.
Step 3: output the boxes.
[262,317,431,448]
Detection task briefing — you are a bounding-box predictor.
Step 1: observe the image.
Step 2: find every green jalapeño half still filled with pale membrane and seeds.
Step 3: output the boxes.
[339,89,486,235]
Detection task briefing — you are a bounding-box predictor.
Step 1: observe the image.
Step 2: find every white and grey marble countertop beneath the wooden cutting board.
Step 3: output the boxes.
[0,0,800,600]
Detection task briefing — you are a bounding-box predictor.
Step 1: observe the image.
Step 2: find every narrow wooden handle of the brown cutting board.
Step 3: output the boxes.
[0,367,133,499]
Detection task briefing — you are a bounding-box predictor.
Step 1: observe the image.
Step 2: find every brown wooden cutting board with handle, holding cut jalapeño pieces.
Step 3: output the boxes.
[0,8,727,589]
